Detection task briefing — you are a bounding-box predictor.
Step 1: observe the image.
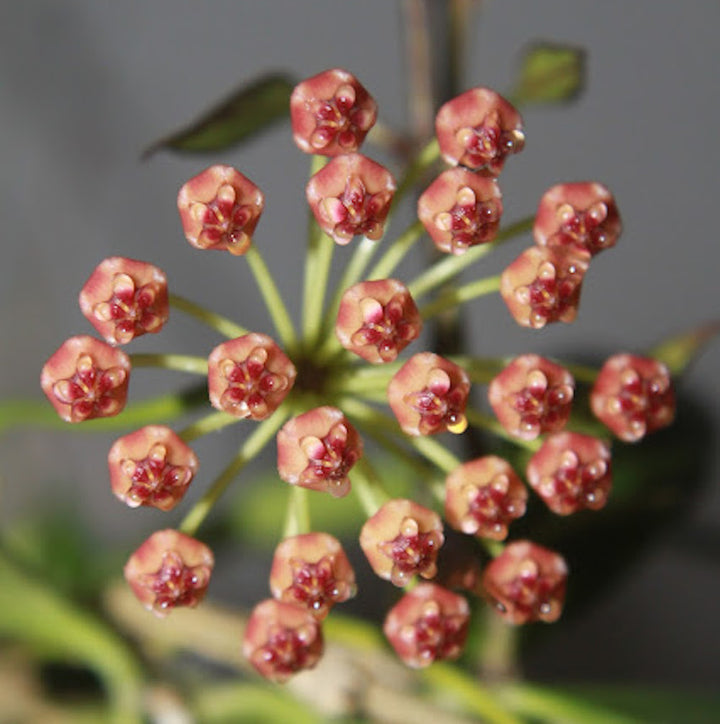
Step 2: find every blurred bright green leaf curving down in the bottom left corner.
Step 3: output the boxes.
[0,552,141,722]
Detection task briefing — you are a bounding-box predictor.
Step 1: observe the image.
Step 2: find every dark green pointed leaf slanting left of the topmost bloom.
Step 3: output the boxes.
[143,74,295,158]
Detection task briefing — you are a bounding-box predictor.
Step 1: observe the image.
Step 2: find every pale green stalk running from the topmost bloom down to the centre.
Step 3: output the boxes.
[302,155,335,349]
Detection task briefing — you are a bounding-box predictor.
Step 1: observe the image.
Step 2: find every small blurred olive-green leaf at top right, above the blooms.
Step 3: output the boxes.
[512,43,585,105]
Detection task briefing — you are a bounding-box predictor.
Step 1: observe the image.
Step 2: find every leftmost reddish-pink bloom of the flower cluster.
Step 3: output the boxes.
[40,335,130,422]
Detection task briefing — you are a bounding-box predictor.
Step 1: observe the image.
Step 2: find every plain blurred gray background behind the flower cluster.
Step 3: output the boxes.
[0,0,720,685]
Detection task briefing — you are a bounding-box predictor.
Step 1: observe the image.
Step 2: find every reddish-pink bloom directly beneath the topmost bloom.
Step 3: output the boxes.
[306,153,395,245]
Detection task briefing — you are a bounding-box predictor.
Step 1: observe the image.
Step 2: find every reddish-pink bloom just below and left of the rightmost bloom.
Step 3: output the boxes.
[527,432,612,515]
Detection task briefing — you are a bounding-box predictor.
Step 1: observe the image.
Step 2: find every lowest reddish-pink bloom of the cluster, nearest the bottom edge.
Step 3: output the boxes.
[243,598,323,684]
